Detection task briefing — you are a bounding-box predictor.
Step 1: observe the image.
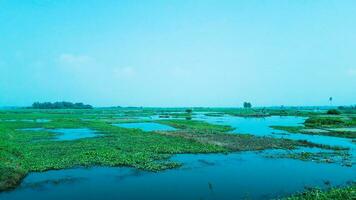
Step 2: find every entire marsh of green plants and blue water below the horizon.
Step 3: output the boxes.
[0,108,356,200]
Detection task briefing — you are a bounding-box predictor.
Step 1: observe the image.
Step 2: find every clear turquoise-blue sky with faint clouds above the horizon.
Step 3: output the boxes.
[0,0,356,107]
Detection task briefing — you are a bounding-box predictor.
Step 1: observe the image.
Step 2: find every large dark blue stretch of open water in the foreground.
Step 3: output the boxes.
[0,152,356,200]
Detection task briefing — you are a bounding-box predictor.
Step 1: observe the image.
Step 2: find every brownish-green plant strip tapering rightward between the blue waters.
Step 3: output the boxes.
[156,120,348,151]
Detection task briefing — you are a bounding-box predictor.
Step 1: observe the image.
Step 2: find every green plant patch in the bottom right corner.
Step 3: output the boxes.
[285,184,356,200]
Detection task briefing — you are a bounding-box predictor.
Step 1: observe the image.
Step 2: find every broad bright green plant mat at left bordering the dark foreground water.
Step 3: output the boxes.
[0,113,226,191]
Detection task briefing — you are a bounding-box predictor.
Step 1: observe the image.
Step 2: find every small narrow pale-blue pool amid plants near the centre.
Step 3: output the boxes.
[114,122,176,131]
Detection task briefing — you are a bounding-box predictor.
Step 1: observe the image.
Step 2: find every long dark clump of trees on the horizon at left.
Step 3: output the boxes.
[29,101,93,109]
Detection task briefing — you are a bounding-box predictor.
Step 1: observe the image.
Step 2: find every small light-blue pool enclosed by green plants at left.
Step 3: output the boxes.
[19,128,99,141]
